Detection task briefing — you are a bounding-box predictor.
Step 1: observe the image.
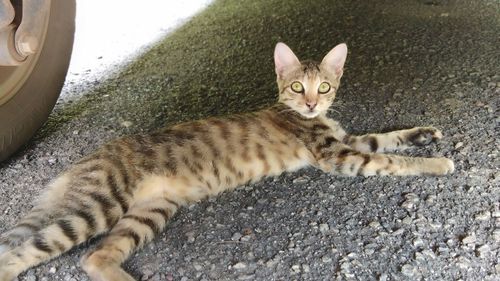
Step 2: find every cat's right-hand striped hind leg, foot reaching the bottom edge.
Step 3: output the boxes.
[81,198,179,281]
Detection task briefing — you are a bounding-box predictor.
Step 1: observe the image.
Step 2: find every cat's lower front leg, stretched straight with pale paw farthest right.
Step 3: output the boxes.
[317,144,455,176]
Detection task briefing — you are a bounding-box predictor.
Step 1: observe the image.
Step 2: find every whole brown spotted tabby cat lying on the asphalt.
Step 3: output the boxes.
[0,43,454,281]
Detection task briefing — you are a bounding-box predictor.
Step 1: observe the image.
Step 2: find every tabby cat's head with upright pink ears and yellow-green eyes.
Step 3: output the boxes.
[274,43,347,118]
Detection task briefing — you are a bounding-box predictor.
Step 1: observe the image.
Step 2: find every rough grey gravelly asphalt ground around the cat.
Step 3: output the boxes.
[0,0,500,281]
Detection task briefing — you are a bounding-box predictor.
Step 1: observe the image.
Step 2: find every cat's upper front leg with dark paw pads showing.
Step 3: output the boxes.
[343,127,443,152]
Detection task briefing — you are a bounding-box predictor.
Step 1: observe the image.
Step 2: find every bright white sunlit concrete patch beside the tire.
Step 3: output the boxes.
[63,0,211,88]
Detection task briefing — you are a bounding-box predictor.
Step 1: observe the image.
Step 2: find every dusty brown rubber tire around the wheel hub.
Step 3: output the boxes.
[0,0,76,161]
